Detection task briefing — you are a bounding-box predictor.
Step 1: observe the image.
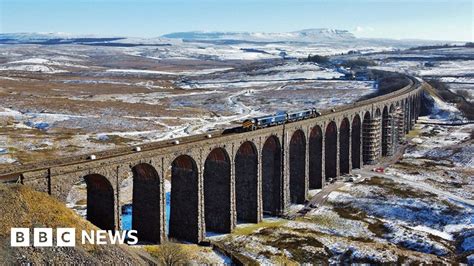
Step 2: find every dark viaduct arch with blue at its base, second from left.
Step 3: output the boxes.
[132,163,163,243]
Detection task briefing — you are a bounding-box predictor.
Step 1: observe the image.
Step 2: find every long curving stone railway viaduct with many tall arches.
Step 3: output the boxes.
[0,78,423,243]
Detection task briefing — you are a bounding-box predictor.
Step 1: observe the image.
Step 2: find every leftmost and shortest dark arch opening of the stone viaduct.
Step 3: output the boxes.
[84,174,115,230]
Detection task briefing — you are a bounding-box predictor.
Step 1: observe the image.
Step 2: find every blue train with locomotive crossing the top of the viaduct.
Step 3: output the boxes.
[242,108,321,131]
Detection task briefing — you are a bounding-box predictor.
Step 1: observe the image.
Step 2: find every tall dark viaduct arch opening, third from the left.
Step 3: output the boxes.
[169,155,201,243]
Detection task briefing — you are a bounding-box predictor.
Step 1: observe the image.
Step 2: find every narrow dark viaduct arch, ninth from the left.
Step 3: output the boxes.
[324,121,337,179]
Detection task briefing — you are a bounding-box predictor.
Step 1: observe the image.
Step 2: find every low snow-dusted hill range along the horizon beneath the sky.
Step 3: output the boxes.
[0,28,447,49]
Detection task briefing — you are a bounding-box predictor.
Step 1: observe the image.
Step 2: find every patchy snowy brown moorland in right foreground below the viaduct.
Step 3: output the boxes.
[214,163,474,263]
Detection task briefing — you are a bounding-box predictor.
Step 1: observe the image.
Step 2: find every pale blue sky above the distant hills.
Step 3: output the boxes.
[0,0,474,41]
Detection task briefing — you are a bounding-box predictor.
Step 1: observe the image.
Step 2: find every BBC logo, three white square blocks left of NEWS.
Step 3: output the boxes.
[10,228,76,247]
